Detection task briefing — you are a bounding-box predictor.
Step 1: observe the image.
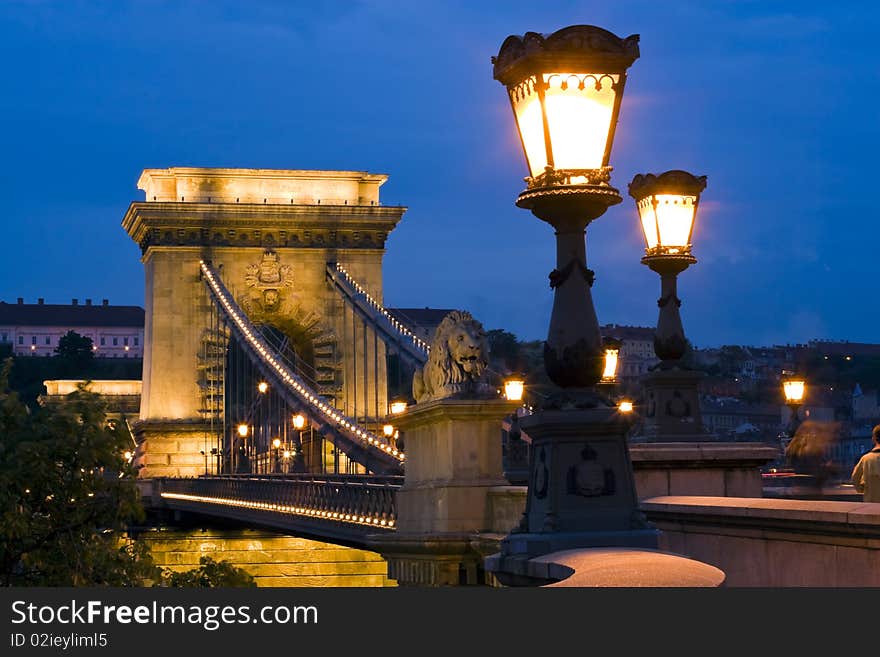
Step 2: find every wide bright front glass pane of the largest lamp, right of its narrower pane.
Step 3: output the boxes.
[544,73,618,169]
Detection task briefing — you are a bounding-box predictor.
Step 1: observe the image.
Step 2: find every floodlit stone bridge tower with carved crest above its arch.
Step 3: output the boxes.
[122,167,406,477]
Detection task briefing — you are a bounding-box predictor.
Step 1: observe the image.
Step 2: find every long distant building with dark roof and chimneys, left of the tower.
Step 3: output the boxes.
[0,297,144,358]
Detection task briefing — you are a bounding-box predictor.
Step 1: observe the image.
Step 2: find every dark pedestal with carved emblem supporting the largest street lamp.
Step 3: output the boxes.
[486,405,657,585]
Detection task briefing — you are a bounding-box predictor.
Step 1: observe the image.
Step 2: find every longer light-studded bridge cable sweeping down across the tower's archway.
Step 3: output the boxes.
[199,260,404,474]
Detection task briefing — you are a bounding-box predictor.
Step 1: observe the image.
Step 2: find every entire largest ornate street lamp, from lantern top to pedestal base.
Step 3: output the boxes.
[485,25,657,584]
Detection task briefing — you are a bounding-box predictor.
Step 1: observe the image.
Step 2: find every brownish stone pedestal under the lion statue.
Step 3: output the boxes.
[370,399,519,586]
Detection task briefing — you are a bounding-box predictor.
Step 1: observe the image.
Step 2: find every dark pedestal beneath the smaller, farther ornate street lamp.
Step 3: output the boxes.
[642,368,706,442]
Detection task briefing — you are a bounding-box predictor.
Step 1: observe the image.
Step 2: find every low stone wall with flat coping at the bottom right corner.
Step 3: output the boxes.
[642,496,880,587]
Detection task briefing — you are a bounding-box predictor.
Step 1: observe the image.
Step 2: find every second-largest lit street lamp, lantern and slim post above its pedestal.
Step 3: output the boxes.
[629,171,706,366]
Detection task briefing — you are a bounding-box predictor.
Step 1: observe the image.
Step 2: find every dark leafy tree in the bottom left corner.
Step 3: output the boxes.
[0,360,156,586]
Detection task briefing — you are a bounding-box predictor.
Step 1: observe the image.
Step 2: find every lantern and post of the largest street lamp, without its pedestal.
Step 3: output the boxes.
[492,25,639,388]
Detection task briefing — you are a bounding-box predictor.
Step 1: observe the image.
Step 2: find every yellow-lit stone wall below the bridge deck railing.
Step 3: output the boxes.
[139,529,395,587]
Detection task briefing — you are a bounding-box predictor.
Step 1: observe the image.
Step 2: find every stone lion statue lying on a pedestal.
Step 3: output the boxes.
[413,310,489,402]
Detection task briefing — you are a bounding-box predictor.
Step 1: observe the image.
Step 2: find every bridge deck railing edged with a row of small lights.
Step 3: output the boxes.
[160,475,403,530]
